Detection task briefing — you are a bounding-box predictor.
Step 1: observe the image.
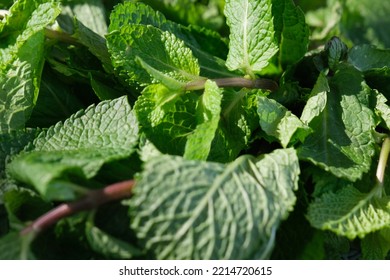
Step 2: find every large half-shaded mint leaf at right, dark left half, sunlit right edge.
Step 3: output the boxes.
[298,66,375,181]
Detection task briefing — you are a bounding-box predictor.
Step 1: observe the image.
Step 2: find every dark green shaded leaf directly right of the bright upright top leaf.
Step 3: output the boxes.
[272,0,309,67]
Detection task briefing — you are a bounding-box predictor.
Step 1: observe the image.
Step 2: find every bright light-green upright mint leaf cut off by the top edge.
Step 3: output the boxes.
[225,0,278,77]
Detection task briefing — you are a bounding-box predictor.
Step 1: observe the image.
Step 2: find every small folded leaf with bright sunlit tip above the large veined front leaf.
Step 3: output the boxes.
[257,96,310,148]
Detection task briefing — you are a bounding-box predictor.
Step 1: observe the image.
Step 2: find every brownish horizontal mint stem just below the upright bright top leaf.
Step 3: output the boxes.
[185,77,278,91]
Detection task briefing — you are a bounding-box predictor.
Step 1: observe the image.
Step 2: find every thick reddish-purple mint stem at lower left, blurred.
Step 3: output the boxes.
[20,180,135,235]
